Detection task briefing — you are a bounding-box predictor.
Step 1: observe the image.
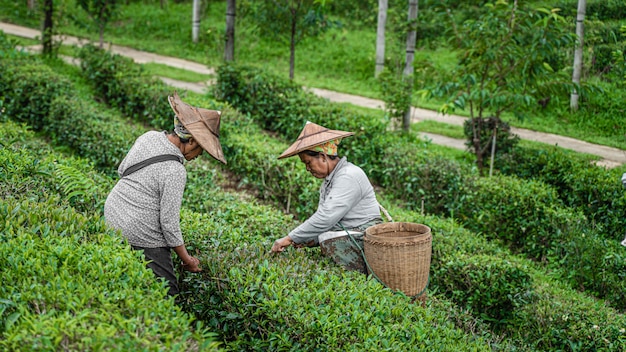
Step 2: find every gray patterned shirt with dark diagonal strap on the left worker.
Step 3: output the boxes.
[104,131,187,248]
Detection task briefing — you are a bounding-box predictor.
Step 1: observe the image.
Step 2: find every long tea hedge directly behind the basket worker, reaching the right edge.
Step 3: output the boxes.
[211,65,626,308]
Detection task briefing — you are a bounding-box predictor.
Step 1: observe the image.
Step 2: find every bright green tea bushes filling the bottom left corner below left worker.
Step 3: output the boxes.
[0,198,217,351]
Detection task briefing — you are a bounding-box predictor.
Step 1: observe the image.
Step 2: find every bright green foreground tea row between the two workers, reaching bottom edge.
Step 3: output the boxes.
[176,208,488,351]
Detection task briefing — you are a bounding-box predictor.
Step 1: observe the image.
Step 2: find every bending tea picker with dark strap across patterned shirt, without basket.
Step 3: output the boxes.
[104,93,226,296]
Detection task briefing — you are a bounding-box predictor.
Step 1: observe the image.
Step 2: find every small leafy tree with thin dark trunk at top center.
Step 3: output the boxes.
[252,0,335,79]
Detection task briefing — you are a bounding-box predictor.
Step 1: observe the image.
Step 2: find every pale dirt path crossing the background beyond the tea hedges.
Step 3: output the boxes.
[0,22,626,167]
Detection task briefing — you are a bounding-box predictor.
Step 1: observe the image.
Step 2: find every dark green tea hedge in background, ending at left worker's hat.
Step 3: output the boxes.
[79,45,174,130]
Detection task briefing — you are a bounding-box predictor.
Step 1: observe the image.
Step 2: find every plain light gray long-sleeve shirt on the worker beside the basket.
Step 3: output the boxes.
[289,157,381,244]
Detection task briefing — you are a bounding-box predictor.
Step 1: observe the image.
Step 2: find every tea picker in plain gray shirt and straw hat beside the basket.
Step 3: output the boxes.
[272,122,382,273]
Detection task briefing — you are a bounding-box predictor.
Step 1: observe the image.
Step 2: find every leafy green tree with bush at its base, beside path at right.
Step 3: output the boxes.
[423,0,575,172]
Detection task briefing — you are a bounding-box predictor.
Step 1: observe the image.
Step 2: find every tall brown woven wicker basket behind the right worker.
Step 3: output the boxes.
[363,222,432,301]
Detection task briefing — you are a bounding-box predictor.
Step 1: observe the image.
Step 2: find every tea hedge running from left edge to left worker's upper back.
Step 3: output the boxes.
[0,57,145,170]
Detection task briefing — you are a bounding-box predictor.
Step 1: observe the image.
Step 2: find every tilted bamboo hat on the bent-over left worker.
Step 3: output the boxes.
[167,93,226,164]
